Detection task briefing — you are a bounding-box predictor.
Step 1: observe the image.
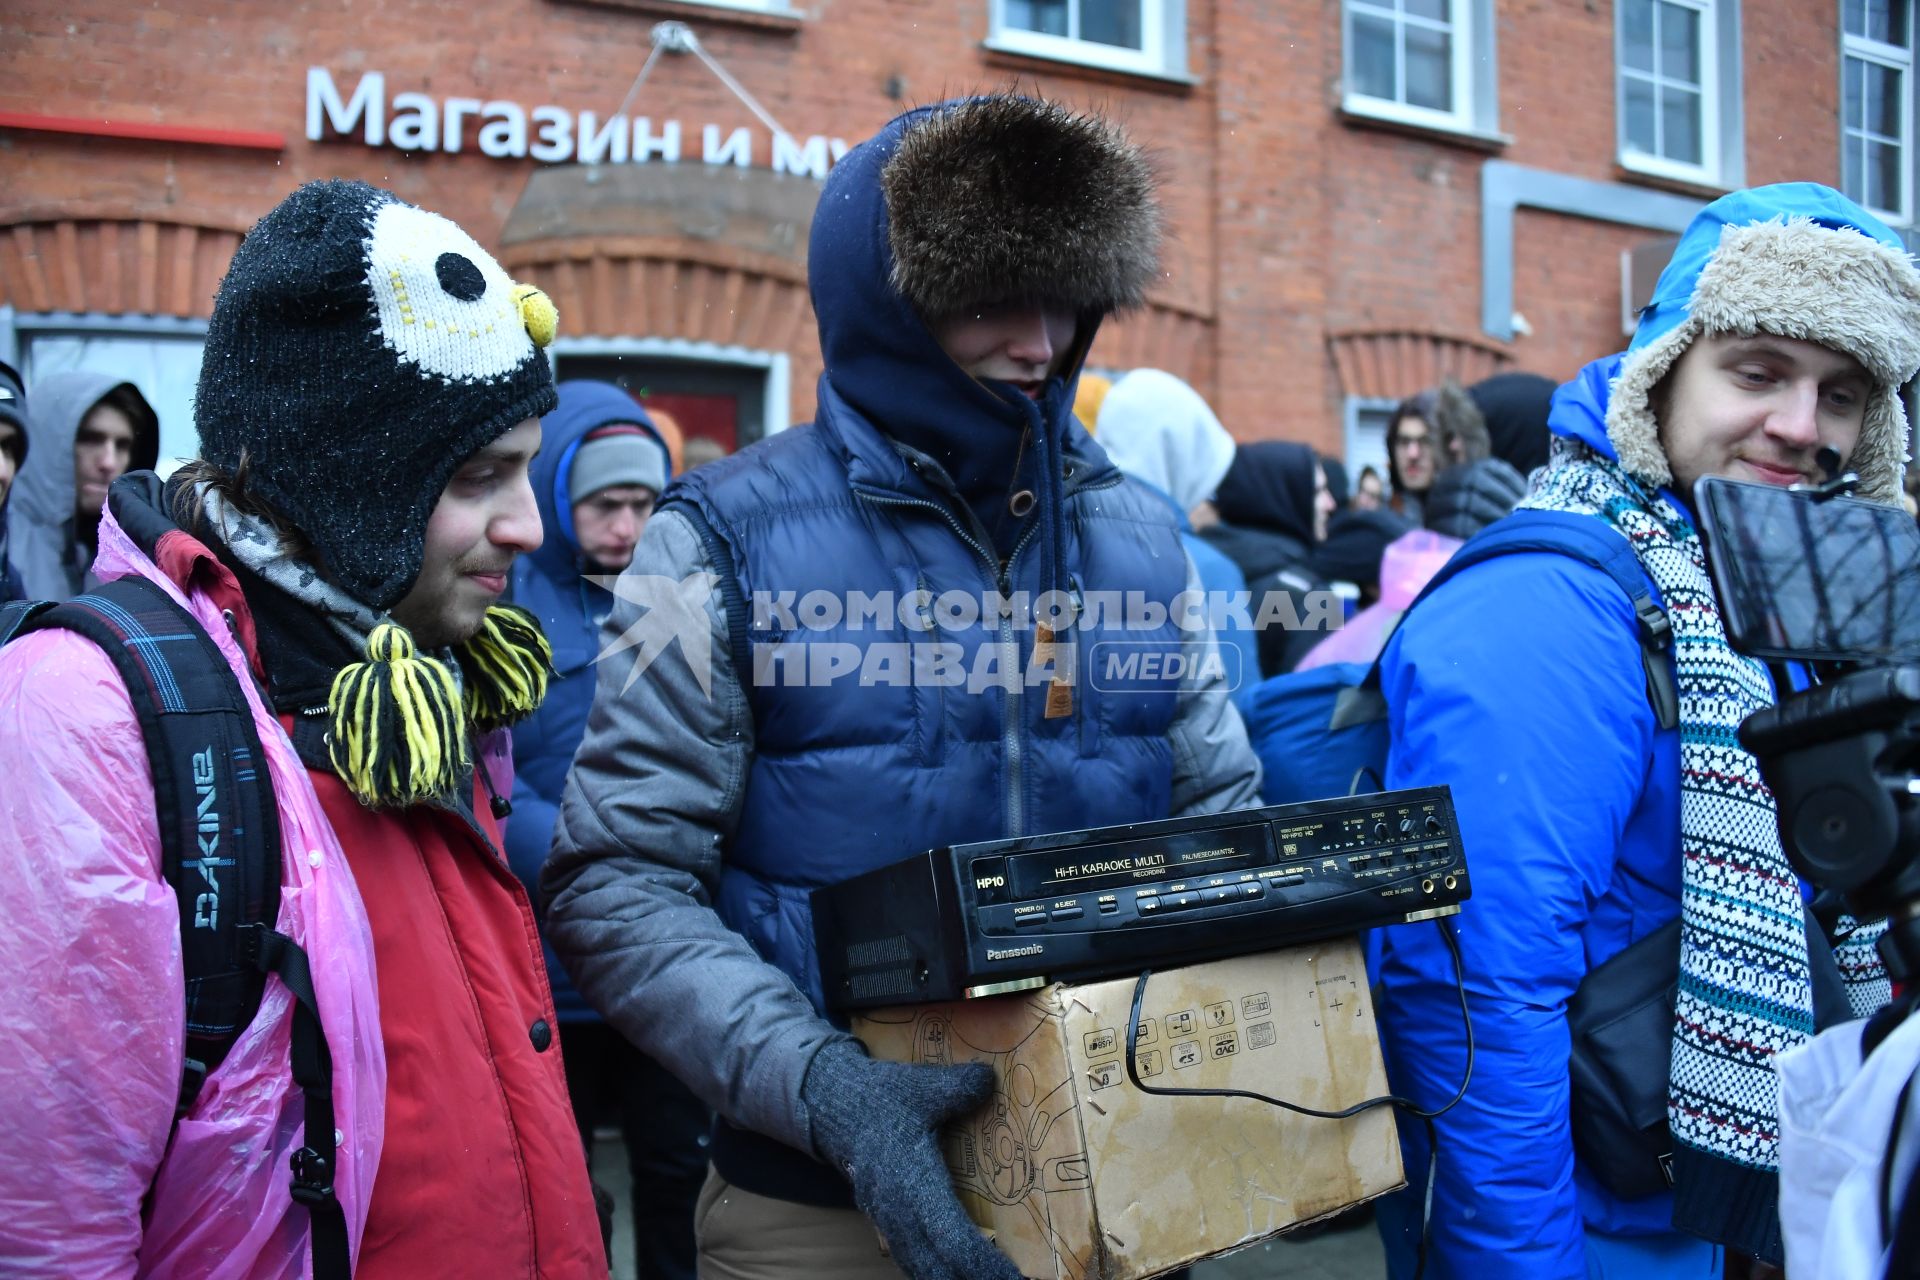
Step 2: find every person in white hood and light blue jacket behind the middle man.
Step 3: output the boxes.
[1081,368,1260,704]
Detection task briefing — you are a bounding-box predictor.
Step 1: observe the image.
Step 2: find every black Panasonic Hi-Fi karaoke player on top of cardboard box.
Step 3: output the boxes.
[812,787,1469,1009]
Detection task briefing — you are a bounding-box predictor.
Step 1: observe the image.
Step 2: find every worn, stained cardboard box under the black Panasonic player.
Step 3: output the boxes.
[852,938,1402,1280]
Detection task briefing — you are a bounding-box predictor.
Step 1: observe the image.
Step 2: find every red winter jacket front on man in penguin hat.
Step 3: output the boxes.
[309,756,607,1280]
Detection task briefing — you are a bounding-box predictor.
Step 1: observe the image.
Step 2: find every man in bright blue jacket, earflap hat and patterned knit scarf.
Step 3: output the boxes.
[1379,182,1920,1280]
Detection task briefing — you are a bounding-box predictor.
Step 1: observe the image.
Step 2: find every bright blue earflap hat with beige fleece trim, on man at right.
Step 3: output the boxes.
[1607,182,1920,503]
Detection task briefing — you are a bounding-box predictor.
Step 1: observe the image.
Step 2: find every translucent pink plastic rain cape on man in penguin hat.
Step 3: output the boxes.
[0,514,386,1280]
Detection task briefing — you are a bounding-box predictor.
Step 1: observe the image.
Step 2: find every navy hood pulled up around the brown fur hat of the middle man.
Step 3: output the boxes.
[806,104,1100,506]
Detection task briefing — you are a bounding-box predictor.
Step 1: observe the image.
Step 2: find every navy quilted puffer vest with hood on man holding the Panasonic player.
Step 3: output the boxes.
[666,115,1187,1007]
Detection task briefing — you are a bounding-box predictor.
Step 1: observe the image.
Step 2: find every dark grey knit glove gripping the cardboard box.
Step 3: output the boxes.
[801,1040,1020,1280]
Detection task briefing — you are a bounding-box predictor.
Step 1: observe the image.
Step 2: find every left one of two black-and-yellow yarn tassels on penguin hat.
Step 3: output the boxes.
[328,622,468,808]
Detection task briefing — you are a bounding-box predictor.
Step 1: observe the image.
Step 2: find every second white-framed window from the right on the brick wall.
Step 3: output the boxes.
[1615,0,1743,186]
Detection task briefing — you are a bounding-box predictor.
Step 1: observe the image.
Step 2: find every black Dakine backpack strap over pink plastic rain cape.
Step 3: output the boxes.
[0,576,351,1280]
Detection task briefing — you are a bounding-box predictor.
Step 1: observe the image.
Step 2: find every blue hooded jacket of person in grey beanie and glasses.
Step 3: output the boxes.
[507,382,666,1023]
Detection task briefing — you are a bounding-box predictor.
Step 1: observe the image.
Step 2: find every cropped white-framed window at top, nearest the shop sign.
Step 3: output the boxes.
[987,0,1187,79]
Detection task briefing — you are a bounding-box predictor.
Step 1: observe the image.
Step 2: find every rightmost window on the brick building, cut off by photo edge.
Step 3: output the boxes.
[1839,0,1914,223]
